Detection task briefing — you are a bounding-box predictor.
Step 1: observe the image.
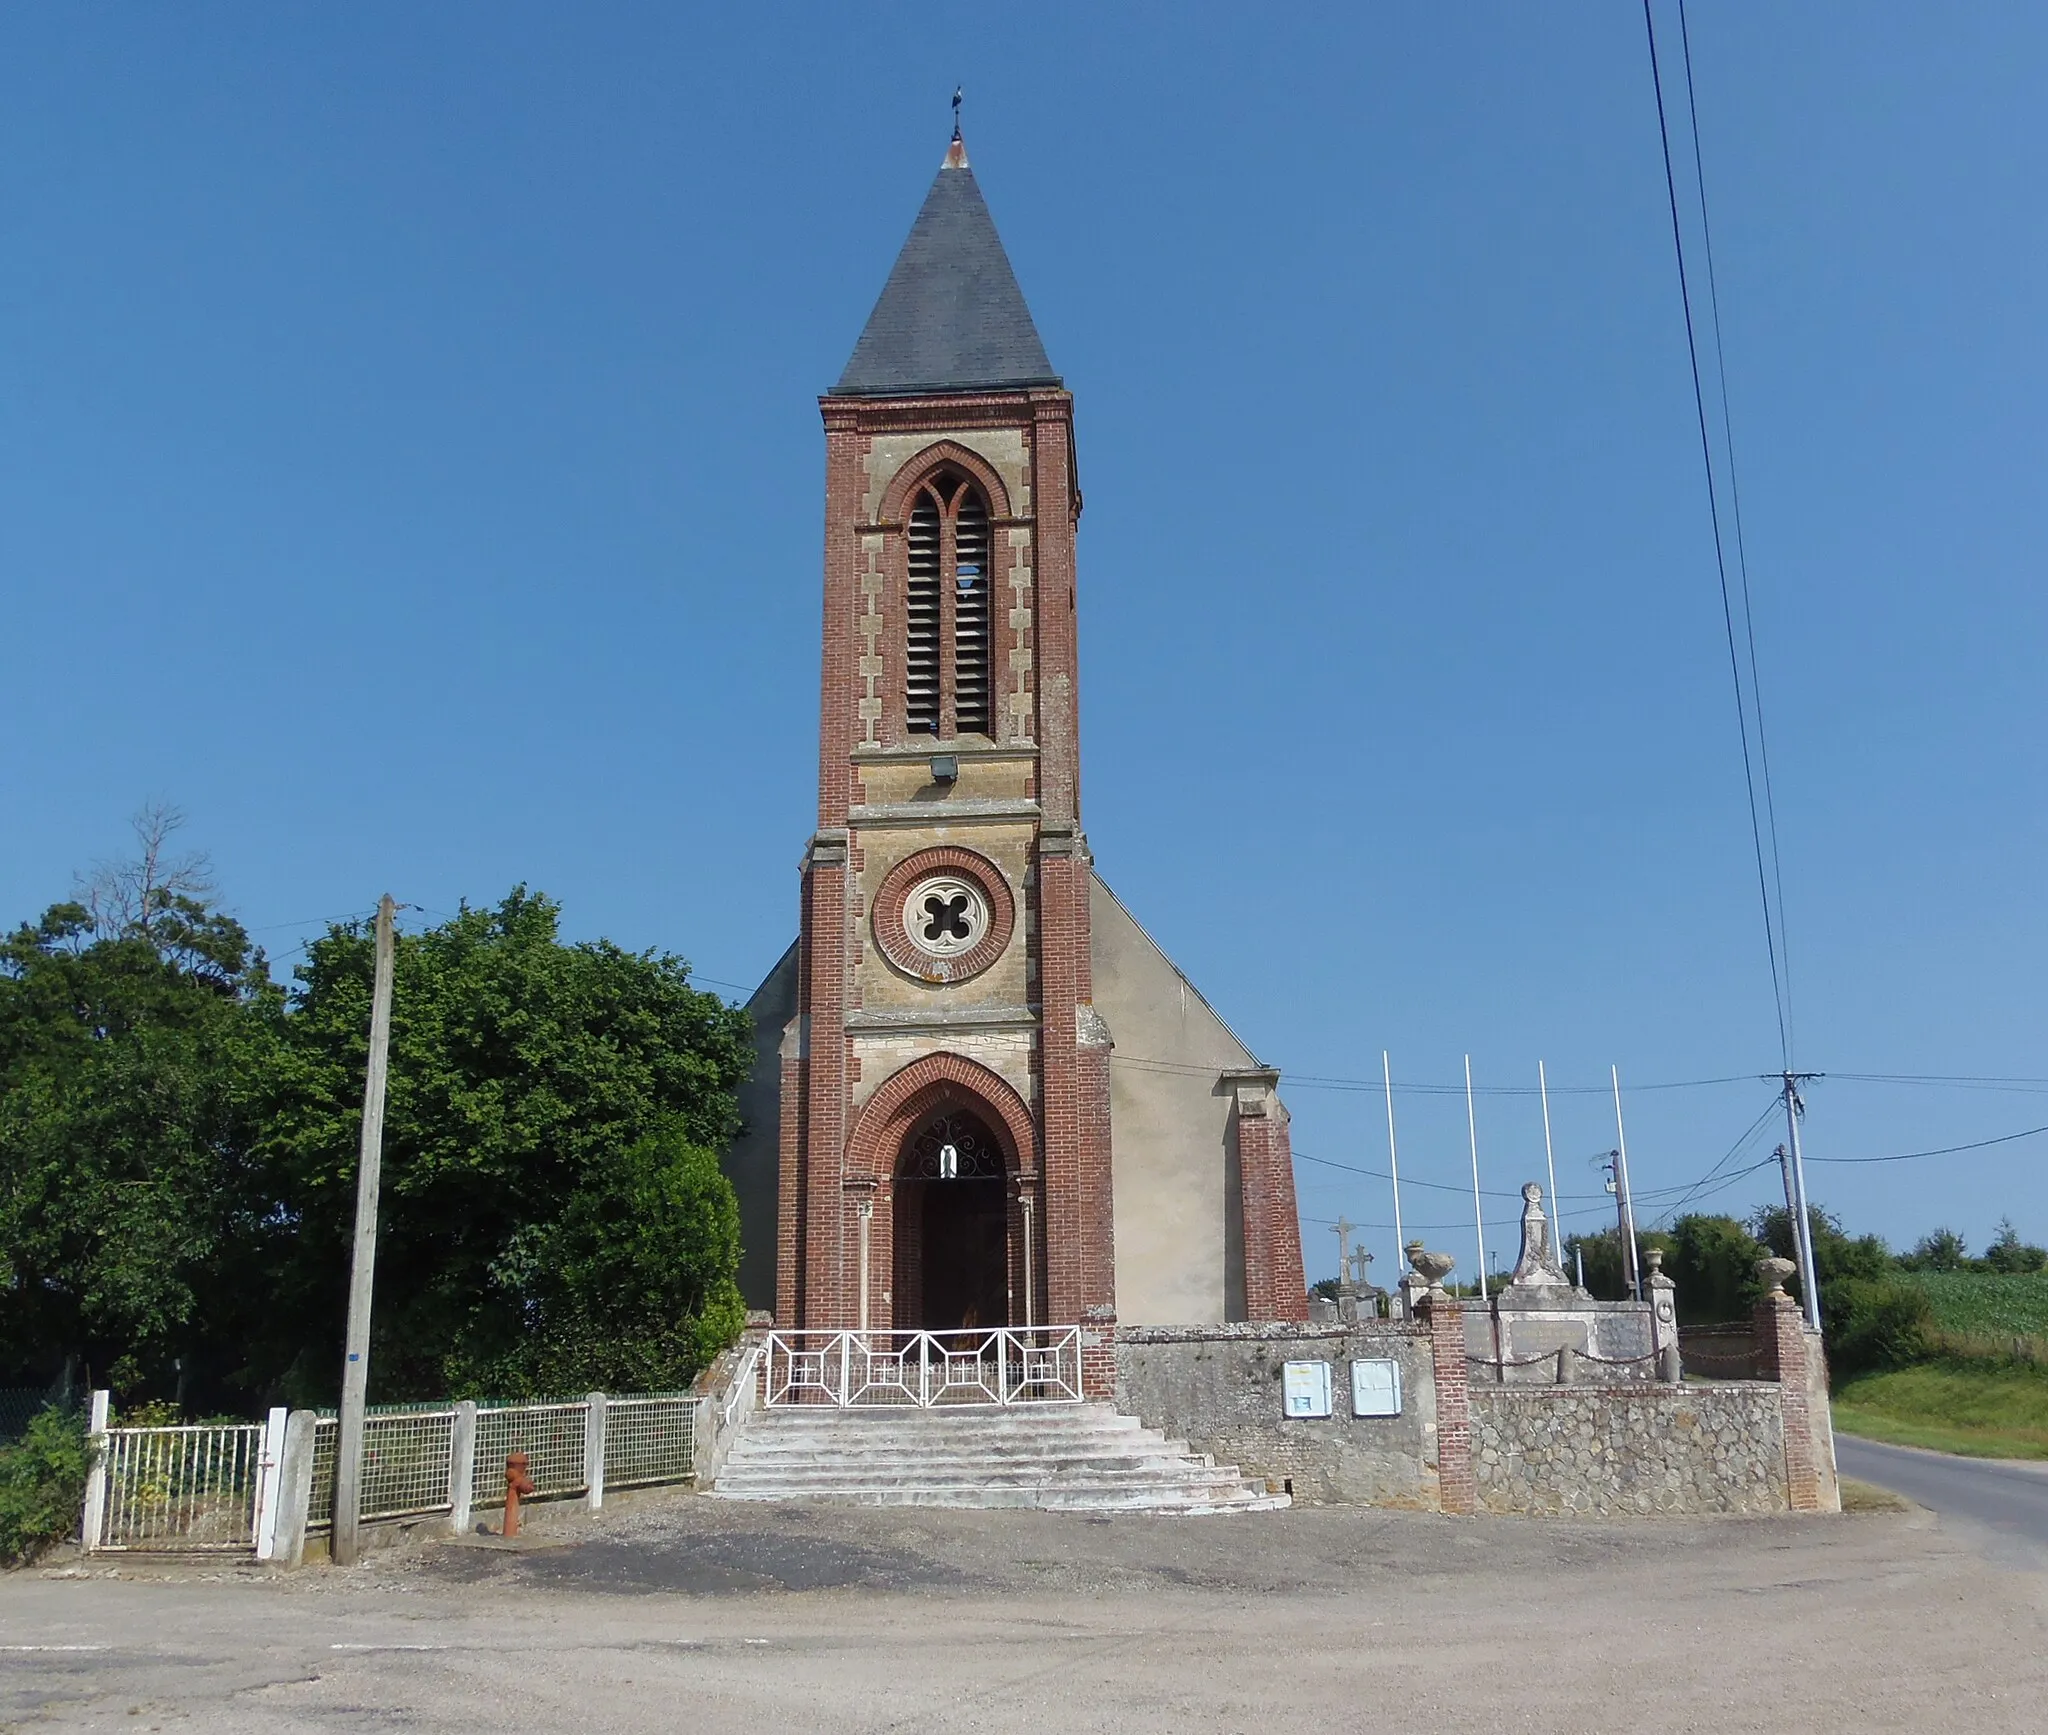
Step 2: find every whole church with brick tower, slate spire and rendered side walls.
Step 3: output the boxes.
[727,129,1307,1395]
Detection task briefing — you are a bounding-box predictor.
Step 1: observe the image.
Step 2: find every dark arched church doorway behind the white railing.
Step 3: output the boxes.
[895,1110,1010,1331]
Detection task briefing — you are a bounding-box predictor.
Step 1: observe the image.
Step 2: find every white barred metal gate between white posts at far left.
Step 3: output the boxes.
[86,1417,285,1553]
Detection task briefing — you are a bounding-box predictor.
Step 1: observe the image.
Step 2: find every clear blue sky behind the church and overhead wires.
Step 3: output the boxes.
[0,0,2048,1274]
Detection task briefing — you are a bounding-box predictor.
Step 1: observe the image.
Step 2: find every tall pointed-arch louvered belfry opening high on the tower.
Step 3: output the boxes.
[903,469,995,735]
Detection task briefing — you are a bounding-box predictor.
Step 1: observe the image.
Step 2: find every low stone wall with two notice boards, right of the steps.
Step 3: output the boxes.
[1116,1321,1438,1512]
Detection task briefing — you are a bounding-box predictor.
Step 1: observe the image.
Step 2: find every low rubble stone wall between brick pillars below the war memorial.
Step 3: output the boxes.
[1470,1381,1790,1514]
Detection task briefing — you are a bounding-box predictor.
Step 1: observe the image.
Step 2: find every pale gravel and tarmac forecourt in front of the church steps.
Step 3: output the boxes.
[0,1495,2048,1735]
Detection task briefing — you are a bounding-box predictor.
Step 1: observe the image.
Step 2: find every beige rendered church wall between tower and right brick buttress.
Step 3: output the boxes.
[1090,877,1257,1325]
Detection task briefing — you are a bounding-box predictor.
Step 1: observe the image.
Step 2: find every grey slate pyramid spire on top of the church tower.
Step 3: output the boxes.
[831,131,1059,397]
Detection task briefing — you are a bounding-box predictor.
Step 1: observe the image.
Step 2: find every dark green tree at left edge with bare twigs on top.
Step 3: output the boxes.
[0,809,276,1395]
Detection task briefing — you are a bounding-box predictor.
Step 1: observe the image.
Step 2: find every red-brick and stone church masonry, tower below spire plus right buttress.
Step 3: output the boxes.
[774,176,1307,1360]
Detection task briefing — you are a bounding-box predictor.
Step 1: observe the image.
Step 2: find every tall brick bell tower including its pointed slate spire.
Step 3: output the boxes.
[774,133,1116,1366]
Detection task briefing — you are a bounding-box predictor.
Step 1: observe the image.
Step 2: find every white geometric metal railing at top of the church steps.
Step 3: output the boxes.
[764,1325,1081,1409]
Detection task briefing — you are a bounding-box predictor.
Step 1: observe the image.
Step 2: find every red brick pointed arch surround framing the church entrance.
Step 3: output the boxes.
[846,1053,1047,1329]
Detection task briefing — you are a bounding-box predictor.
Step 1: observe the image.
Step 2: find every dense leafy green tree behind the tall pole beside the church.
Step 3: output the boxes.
[250,887,752,1401]
